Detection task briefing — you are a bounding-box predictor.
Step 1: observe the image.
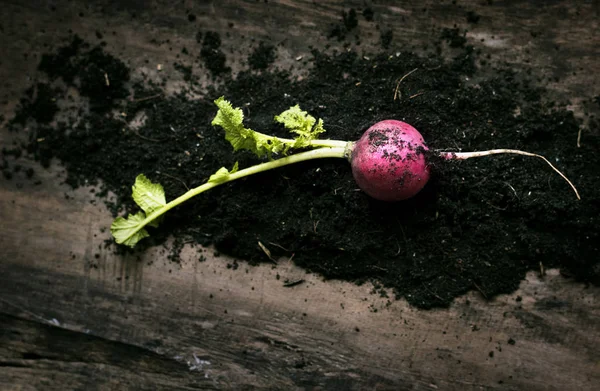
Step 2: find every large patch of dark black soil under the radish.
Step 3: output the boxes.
[1,25,600,308]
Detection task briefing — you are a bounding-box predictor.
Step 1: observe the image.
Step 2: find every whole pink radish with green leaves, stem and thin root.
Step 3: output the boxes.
[111,97,581,247]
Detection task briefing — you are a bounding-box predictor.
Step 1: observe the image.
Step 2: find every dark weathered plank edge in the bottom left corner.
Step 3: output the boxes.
[0,315,214,390]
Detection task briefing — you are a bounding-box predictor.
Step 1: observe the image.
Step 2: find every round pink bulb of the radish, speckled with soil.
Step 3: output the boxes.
[350,120,430,201]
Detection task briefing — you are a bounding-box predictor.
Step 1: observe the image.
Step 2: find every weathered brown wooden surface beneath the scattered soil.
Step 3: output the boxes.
[0,0,600,390]
